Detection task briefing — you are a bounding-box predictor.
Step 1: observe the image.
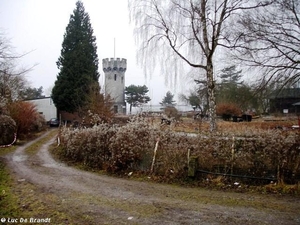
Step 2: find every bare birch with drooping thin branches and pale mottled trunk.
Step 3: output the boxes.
[129,0,266,131]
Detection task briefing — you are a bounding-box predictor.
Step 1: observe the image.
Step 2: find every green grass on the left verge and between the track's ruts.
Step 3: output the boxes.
[0,130,76,224]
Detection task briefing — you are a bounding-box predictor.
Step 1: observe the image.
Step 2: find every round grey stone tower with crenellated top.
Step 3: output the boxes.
[102,58,127,114]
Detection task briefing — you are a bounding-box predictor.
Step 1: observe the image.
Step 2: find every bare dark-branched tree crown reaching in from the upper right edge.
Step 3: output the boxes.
[234,0,300,86]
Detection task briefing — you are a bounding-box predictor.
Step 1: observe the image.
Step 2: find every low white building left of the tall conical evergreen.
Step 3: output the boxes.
[26,97,57,121]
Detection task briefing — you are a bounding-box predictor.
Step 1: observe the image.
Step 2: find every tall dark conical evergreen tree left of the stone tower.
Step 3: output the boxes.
[52,1,100,113]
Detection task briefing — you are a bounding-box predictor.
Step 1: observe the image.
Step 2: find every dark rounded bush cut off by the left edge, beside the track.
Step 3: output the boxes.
[0,115,17,145]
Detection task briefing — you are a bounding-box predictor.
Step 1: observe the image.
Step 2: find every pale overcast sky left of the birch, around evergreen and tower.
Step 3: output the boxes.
[0,0,185,104]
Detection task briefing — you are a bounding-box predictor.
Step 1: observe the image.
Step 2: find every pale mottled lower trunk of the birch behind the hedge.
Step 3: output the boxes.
[206,62,217,132]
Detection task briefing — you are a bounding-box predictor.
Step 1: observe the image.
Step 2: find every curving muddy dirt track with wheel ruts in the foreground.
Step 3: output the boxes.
[6,131,300,225]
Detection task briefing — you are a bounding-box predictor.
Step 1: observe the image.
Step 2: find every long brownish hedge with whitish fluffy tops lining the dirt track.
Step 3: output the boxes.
[60,117,300,183]
